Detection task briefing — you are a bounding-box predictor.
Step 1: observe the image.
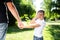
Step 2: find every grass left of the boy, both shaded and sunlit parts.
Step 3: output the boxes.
[6,26,33,40]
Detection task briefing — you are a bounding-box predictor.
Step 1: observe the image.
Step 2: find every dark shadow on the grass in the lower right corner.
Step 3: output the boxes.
[48,25,60,40]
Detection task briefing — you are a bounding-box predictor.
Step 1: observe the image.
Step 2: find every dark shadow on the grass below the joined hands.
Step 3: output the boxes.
[7,26,33,34]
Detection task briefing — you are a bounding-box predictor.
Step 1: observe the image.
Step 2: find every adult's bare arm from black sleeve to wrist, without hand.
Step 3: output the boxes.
[7,2,21,22]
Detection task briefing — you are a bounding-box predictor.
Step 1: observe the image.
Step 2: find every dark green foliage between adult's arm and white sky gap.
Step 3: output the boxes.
[14,0,35,18]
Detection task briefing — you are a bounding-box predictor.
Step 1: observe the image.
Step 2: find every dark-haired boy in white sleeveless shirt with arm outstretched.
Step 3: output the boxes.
[24,10,46,40]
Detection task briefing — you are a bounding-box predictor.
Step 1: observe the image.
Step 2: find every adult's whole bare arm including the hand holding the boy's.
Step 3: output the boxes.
[6,2,23,28]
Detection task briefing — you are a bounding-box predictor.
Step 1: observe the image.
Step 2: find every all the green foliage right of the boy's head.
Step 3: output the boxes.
[44,0,60,20]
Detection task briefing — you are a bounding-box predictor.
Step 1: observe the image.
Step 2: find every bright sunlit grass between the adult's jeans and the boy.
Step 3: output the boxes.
[6,30,33,40]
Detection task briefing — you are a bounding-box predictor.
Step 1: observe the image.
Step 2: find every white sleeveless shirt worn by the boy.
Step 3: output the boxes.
[34,19,46,37]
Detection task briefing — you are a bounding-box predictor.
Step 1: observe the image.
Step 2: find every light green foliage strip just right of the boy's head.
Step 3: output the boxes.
[44,0,52,20]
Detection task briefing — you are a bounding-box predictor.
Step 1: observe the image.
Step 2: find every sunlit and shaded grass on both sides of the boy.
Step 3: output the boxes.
[6,26,60,40]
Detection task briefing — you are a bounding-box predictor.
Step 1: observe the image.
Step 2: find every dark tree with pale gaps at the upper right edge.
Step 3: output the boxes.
[52,0,60,19]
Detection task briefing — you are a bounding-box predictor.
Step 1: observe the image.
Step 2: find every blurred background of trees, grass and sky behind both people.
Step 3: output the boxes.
[6,0,60,40]
